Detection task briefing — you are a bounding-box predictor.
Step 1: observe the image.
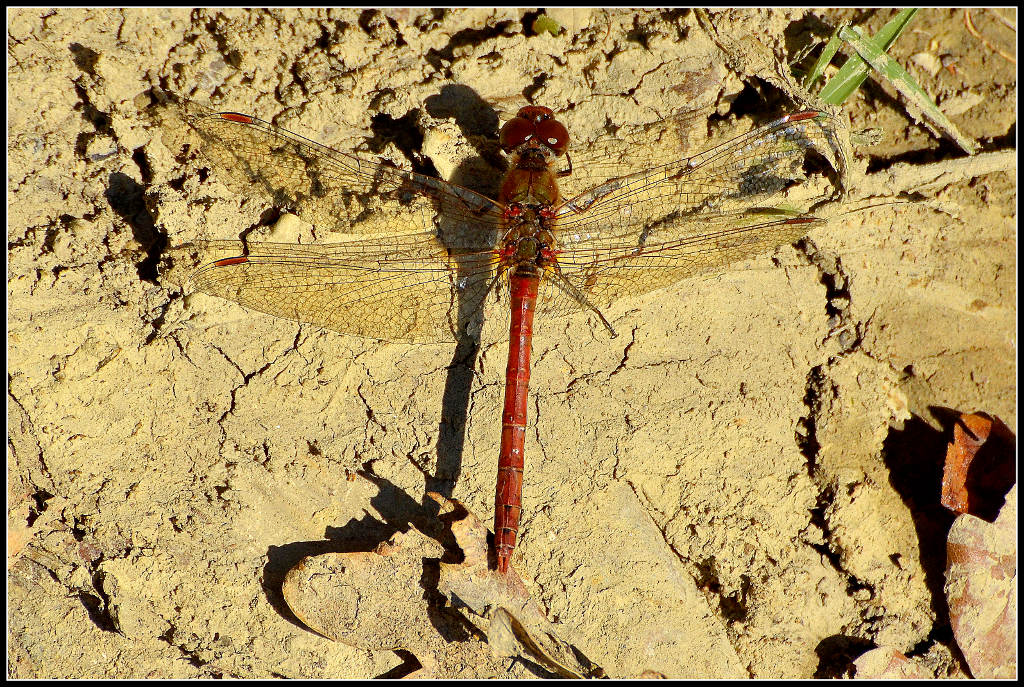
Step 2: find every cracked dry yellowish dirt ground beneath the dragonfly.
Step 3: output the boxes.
[7,9,1017,678]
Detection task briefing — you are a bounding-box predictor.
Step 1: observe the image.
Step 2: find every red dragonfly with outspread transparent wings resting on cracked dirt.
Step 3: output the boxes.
[157,91,846,573]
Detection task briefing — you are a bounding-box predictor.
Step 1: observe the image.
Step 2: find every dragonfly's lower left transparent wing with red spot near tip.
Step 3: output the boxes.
[170,233,496,342]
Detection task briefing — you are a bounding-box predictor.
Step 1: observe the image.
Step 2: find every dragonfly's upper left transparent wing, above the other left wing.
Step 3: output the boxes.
[160,95,502,250]
